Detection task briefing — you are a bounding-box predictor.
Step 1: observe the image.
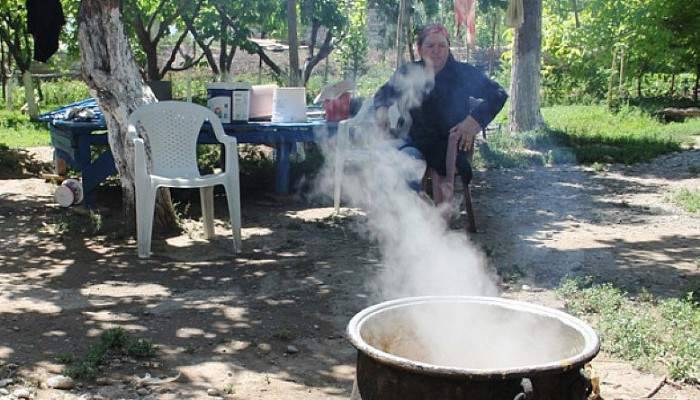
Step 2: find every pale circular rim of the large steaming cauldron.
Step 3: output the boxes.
[346,296,600,380]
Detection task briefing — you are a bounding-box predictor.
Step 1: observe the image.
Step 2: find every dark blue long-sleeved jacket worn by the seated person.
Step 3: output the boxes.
[374,54,508,175]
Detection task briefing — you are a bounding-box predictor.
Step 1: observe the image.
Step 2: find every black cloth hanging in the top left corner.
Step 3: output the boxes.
[27,0,66,62]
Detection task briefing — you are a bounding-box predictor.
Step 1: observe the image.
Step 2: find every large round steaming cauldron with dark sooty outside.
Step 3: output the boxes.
[347,296,600,400]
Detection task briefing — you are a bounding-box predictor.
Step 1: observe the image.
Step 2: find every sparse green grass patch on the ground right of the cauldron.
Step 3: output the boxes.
[557,279,700,383]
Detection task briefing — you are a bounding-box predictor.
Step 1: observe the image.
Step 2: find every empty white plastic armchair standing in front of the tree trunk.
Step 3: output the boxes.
[129,101,241,258]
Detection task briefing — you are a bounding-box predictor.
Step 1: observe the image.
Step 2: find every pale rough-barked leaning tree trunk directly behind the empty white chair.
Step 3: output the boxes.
[78,0,176,232]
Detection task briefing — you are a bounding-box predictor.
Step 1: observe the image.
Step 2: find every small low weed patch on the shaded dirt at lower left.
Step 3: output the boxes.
[63,328,156,379]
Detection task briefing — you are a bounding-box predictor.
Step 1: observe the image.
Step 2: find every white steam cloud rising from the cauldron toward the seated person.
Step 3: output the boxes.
[318,68,498,300]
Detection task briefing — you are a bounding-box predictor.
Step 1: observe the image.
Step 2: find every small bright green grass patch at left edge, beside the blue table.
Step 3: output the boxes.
[0,110,51,149]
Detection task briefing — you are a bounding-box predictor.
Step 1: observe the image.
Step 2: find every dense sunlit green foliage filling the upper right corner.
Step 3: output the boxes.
[542,0,700,104]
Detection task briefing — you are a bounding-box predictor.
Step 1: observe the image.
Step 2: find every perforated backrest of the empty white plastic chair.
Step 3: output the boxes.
[129,101,221,178]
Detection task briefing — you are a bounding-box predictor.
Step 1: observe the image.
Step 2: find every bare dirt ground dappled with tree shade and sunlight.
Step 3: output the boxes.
[0,150,700,400]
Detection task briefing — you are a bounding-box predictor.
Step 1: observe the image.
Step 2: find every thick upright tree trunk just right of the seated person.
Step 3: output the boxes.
[508,0,544,133]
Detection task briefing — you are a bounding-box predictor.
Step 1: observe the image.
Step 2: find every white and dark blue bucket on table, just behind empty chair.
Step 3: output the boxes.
[207,82,251,124]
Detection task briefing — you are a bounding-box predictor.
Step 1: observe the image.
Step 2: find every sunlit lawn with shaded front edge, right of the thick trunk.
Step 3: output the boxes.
[542,105,700,164]
